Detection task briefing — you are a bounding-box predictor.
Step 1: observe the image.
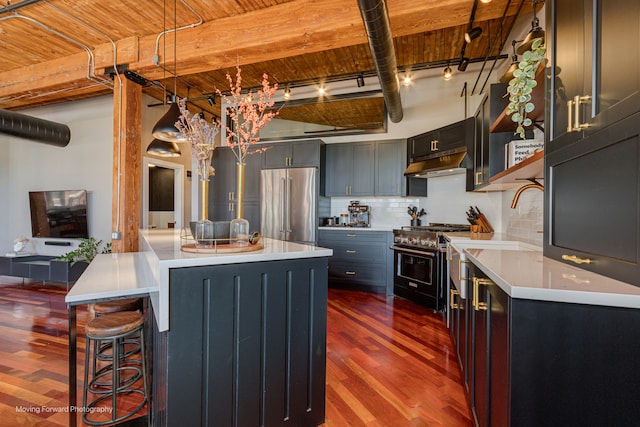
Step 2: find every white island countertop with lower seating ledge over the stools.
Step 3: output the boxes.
[65,229,333,331]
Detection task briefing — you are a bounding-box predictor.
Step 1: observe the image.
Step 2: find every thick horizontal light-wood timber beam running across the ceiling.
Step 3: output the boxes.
[0,0,524,108]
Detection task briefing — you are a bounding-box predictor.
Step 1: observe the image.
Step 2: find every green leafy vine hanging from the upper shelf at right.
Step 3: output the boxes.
[507,39,546,139]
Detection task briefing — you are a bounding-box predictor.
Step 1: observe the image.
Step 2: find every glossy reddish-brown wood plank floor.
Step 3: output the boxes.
[0,277,472,427]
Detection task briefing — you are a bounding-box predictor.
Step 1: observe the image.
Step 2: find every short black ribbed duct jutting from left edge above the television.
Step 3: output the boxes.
[0,109,71,147]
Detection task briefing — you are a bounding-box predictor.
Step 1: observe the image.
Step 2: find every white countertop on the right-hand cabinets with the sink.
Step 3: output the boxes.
[447,233,640,308]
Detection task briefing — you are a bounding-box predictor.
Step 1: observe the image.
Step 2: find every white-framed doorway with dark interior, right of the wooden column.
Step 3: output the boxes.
[142,157,184,228]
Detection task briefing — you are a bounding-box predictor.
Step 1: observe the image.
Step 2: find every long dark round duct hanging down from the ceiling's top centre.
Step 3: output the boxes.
[358,0,402,123]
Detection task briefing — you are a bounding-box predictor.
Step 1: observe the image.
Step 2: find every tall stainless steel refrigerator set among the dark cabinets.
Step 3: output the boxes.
[260,168,318,245]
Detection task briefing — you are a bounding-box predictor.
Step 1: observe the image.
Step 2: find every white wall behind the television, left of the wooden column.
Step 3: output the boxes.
[0,96,113,255]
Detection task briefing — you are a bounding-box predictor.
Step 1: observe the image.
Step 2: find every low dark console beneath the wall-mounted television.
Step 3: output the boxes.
[0,255,89,289]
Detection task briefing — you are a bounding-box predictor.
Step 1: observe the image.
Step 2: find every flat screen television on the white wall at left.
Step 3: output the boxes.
[29,190,89,239]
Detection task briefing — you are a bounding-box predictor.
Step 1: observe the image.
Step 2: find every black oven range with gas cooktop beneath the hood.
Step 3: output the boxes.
[391,224,469,311]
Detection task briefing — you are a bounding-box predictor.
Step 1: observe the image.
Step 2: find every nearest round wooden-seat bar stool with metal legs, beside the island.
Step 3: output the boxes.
[82,311,149,426]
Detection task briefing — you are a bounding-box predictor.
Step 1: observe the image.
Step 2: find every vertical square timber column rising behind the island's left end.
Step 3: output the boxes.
[111,77,142,252]
